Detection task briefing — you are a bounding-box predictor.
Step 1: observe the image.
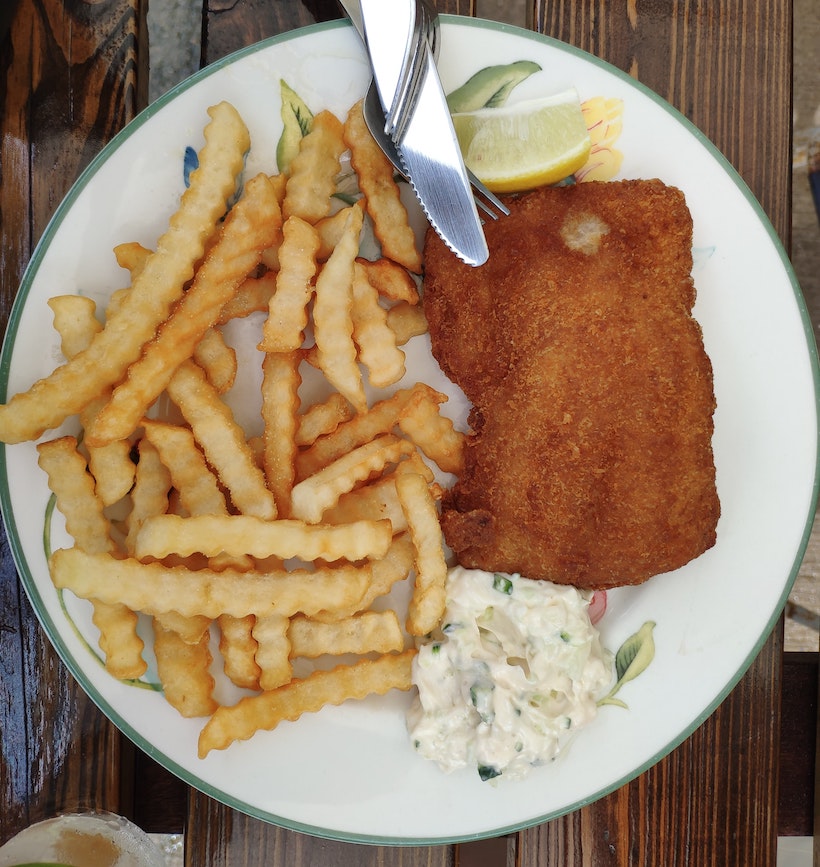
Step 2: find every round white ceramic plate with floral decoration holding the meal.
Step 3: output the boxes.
[0,18,817,844]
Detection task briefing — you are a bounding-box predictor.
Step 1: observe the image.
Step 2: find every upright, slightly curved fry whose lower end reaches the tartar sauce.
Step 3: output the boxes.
[396,473,447,635]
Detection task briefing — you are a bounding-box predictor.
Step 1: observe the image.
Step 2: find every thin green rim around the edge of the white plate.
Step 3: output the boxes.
[0,15,820,846]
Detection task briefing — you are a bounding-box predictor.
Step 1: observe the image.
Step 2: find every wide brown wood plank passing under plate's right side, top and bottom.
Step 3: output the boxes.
[519,0,791,867]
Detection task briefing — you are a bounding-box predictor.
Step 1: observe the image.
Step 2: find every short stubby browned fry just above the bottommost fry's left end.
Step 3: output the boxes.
[154,620,218,717]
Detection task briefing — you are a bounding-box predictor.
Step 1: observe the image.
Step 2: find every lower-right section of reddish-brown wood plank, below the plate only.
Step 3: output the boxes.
[518,624,782,867]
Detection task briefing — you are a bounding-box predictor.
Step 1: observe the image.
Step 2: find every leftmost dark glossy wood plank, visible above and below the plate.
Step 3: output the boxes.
[0,0,144,842]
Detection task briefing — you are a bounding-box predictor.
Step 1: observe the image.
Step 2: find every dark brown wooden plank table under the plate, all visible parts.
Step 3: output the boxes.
[0,0,817,867]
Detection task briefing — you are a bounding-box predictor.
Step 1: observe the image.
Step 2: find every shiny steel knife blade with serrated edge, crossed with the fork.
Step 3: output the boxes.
[354,0,489,266]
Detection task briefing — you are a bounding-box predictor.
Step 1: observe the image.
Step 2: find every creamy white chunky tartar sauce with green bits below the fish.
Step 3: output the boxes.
[407,567,612,780]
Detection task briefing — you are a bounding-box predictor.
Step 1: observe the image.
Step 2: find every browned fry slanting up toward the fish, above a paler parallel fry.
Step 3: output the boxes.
[296,383,429,479]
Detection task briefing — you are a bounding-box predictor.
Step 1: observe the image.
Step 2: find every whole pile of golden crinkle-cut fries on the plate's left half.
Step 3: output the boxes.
[0,102,464,757]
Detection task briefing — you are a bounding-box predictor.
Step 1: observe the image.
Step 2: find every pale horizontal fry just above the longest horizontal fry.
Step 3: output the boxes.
[136,515,392,562]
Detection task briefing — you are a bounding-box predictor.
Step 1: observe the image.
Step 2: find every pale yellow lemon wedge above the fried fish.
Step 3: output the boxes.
[453,90,590,193]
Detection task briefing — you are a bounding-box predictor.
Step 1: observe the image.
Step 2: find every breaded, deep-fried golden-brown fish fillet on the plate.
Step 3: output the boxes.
[424,181,720,588]
